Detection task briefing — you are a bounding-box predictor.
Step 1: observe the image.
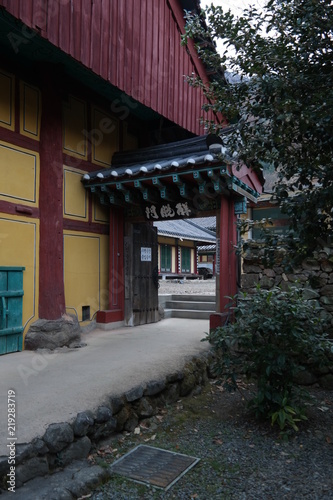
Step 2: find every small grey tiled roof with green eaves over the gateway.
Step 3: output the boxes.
[82,131,261,211]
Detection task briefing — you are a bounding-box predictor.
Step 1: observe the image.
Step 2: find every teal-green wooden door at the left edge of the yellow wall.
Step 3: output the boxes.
[0,267,24,354]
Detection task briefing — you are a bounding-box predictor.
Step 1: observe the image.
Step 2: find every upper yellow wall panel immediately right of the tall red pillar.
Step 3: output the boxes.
[63,96,88,159]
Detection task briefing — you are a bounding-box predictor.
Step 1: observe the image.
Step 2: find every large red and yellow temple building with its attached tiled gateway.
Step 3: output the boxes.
[0,0,262,352]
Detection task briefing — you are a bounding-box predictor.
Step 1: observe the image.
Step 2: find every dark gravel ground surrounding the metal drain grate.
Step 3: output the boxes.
[91,383,333,500]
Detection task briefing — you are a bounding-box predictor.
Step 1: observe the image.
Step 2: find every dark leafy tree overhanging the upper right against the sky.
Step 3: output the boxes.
[182,0,333,262]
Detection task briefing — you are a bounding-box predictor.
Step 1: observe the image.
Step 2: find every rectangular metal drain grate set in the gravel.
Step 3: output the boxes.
[110,444,200,491]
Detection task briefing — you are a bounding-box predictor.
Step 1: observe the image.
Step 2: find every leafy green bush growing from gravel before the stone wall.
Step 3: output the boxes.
[204,286,333,431]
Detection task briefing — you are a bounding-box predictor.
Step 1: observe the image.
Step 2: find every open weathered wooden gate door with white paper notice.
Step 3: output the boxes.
[125,223,159,326]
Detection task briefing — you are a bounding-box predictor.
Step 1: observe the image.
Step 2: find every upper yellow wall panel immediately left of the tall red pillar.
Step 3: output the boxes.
[20,82,41,140]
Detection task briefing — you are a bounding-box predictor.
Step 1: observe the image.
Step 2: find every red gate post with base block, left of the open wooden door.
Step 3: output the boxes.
[96,208,125,323]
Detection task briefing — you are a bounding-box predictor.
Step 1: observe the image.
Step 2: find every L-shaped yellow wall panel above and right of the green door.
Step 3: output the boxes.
[0,213,39,334]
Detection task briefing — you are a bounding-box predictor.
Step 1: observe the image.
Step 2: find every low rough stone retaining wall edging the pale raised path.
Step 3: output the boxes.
[0,353,212,494]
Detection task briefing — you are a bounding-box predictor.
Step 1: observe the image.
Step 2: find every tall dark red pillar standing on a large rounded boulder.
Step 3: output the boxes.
[39,76,66,320]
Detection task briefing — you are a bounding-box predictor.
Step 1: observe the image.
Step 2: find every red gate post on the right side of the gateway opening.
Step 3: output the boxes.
[219,197,237,313]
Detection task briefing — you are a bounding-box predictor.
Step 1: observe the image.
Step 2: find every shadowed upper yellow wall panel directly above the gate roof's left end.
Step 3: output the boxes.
[90,108,119,167]
